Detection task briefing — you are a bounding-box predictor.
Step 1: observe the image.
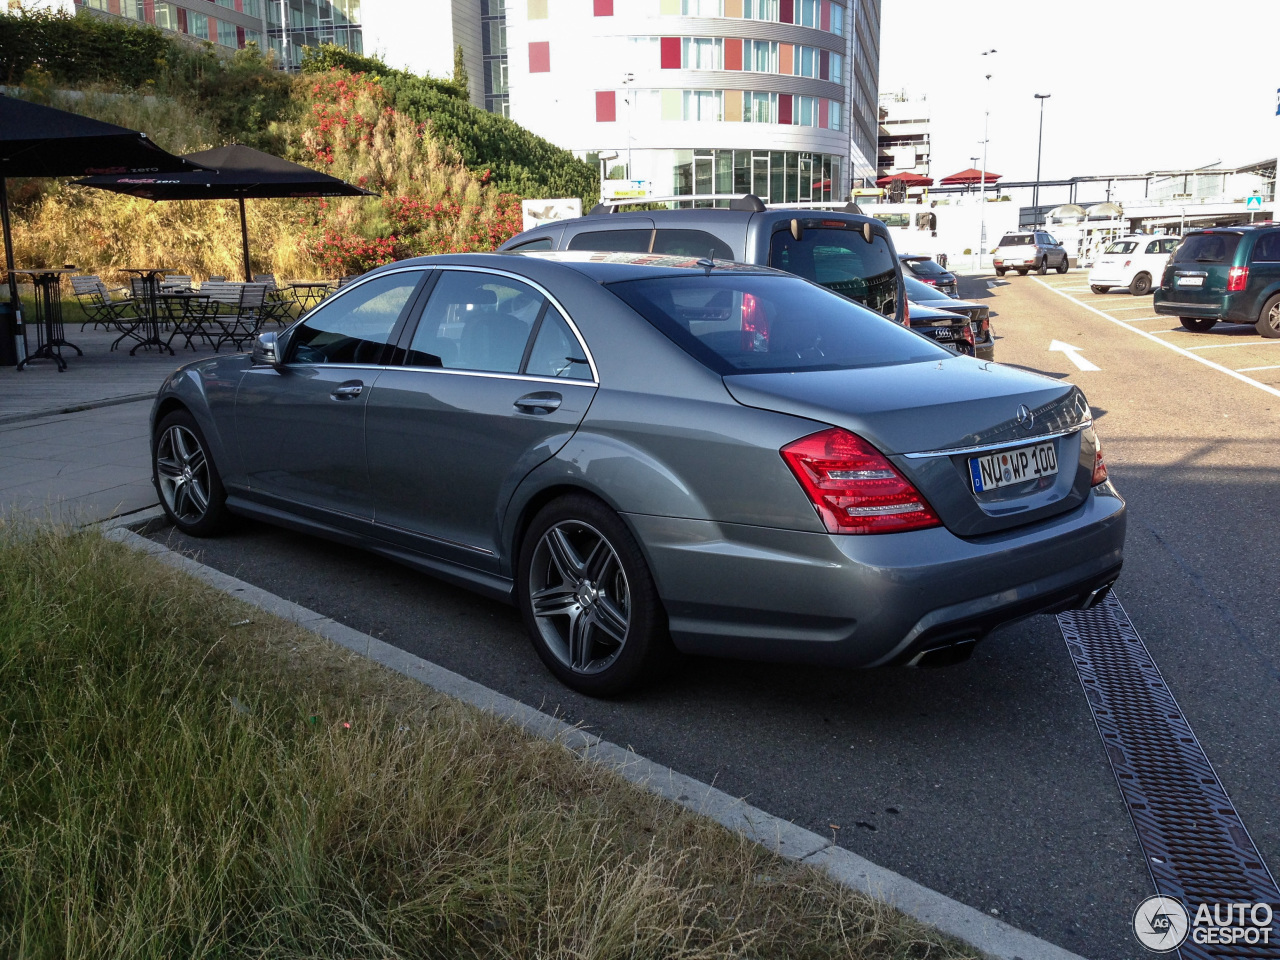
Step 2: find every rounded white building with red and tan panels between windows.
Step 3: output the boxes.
[451,0,879,202]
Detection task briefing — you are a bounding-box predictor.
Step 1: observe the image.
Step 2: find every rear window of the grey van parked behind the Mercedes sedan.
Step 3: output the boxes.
[769,227,899,316]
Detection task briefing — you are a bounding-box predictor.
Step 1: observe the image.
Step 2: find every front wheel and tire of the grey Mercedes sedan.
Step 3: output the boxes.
[151,410,232,536]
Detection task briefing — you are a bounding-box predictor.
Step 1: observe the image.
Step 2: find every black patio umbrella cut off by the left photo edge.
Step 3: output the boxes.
[0,96,201,340]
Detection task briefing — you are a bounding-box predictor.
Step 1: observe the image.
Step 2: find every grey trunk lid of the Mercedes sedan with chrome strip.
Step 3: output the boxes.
[724,357,1097,536]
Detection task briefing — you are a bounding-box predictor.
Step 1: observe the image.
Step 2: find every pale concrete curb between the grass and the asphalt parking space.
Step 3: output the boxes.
[102,519,1083,960]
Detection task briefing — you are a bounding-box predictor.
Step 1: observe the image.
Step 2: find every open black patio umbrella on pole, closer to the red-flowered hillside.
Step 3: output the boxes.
[76,143,378,280]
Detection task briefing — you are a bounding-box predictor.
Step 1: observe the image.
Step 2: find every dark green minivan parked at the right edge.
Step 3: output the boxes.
[1155,223,1280,338]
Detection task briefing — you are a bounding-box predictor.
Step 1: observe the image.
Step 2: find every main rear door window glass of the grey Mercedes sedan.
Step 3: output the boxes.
[404,270,547,374]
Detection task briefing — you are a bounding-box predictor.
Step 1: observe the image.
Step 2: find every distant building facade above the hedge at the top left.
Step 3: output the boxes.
[74,0,364,69]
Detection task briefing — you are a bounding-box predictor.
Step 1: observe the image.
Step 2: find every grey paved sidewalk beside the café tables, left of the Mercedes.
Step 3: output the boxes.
[0,328,210,525]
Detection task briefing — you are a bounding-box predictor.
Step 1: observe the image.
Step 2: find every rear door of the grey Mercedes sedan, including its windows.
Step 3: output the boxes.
[366,268,596,572]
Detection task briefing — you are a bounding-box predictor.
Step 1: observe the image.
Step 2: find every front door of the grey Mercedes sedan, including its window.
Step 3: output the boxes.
[236,268,426,527]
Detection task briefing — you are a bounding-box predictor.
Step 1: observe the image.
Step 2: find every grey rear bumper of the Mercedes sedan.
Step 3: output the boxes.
[627,484,1125,667]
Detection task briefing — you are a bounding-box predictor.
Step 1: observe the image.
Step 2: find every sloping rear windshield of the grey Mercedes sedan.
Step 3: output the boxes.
[608,273,952,376]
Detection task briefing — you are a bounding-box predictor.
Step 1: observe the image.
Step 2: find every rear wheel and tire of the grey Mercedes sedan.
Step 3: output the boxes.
[516,494,673,696]
